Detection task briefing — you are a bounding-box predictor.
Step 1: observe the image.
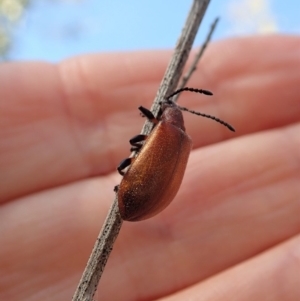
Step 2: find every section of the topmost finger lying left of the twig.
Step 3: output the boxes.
[0,53,169,202]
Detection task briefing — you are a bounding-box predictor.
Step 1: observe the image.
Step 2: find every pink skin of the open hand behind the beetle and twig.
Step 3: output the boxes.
[0,35,300,301]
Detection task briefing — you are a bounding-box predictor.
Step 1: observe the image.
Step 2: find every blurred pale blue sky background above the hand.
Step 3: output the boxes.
[0,0,300,62]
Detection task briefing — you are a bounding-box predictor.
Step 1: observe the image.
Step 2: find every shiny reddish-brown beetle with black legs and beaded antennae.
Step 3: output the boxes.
[115,87,235,221]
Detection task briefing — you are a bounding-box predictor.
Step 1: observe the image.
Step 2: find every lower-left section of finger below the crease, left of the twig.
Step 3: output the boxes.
[0,179,113,301]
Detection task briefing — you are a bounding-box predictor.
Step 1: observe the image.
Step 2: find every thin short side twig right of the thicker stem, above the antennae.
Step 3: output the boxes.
[173,18,219,102]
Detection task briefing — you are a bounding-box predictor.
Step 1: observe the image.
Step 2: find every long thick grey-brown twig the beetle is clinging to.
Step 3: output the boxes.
[72,0,210,301]
